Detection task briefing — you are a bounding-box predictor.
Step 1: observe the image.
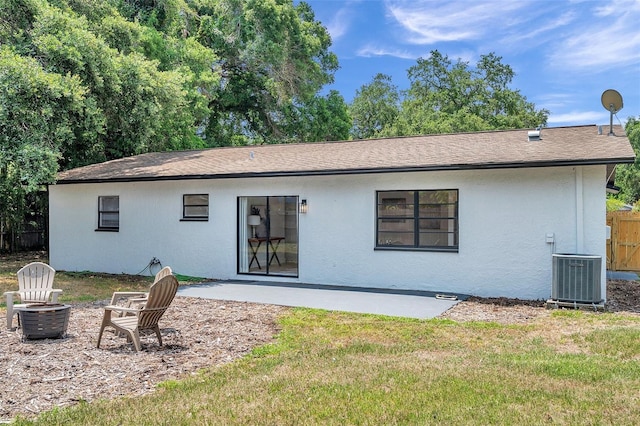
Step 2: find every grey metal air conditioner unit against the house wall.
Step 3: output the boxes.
[551,254,602,303]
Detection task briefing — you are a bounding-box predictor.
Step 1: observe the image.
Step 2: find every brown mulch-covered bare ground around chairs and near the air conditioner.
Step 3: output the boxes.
[0,281,640,422]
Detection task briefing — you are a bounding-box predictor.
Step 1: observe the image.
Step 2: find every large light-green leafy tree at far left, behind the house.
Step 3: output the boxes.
[0,0,219,250]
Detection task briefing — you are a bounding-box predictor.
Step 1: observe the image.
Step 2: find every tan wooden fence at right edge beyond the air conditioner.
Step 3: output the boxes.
[607,211,640,272]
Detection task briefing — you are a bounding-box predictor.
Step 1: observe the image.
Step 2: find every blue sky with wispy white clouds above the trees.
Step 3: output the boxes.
[307,0,640,127]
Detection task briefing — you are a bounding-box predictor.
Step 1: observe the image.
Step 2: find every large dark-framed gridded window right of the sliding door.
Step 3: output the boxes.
[376,189,458,251]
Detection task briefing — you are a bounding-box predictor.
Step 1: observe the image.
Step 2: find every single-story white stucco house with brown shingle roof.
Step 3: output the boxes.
[49,125,634,299]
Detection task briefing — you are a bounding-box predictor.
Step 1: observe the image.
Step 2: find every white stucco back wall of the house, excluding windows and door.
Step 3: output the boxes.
[49,166,606,299]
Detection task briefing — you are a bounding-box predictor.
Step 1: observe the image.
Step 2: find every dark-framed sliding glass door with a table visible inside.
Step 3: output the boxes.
[238,196,298,277]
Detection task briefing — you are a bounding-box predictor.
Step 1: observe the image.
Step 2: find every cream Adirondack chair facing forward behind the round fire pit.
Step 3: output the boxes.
[4,262,62,329]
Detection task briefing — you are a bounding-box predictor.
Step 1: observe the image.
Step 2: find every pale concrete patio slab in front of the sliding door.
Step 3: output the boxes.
[178,281,466,319]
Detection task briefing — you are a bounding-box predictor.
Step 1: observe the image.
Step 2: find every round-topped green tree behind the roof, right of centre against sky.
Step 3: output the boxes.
[350,50,549,138]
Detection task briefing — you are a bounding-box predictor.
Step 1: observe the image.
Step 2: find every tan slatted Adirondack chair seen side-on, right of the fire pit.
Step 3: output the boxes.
[96,275,178,352]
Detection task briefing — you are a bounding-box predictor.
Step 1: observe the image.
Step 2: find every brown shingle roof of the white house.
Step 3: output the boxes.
[58,125,634,184]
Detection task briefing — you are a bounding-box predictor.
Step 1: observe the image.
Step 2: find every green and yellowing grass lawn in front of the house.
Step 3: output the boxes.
[5,255,640,425]
